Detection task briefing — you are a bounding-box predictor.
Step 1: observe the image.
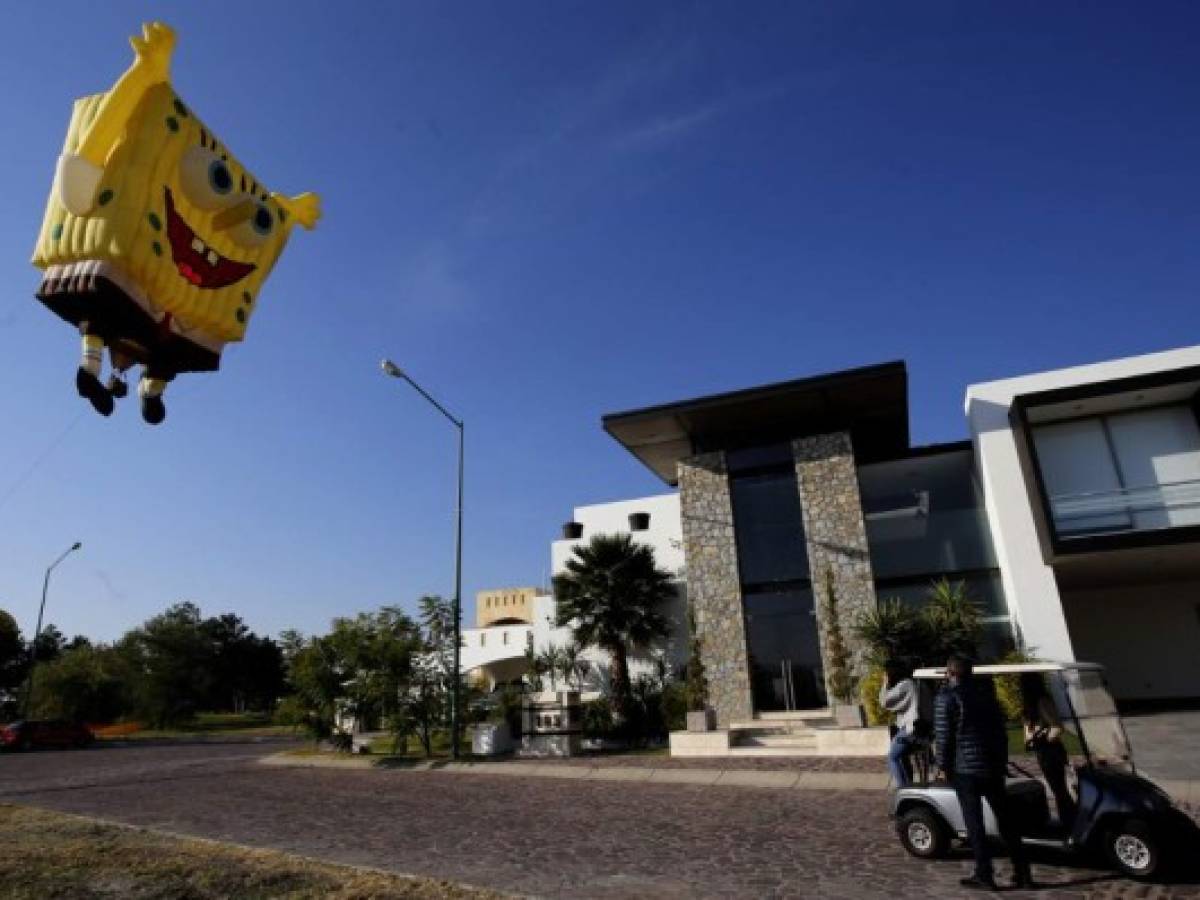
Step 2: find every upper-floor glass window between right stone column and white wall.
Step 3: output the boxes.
[858,449,996,578]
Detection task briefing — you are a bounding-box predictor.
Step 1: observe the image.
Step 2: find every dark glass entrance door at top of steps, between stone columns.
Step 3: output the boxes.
[744,587,826,713]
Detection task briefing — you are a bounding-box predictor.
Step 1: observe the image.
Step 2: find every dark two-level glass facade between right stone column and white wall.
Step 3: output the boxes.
[858,448,1013,656]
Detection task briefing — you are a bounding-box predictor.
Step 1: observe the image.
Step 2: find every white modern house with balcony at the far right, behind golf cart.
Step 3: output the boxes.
[966,347,1200,700]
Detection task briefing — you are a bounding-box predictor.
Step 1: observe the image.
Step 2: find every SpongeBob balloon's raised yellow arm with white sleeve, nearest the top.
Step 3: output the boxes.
[59,22,175,215]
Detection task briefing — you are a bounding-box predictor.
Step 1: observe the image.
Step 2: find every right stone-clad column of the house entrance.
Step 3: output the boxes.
[792,432,876,702]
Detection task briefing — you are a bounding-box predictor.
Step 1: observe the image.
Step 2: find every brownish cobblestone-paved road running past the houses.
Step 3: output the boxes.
[0,744,1200,898]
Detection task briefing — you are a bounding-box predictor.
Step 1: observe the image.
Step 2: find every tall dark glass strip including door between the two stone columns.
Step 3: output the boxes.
[730,460,824,712]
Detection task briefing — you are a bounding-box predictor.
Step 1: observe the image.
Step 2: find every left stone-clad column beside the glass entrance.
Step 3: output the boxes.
[679,452,754,727]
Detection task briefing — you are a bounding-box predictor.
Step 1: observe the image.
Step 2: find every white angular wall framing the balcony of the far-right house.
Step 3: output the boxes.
[966,347,1200,661]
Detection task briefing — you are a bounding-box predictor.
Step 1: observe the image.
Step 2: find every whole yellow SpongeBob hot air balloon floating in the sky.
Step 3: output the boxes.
[34,23,320,425]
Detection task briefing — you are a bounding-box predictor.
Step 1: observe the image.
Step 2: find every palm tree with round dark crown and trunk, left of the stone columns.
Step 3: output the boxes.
[554,534,674,721]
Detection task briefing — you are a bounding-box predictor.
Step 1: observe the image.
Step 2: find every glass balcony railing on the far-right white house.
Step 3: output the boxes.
[1050,479,1200,538]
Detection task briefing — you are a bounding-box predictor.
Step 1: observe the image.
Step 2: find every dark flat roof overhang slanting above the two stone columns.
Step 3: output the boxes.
[601,360,908,485]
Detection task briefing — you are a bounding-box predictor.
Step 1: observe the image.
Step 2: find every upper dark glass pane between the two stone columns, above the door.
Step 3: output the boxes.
[730,468,809,584]
